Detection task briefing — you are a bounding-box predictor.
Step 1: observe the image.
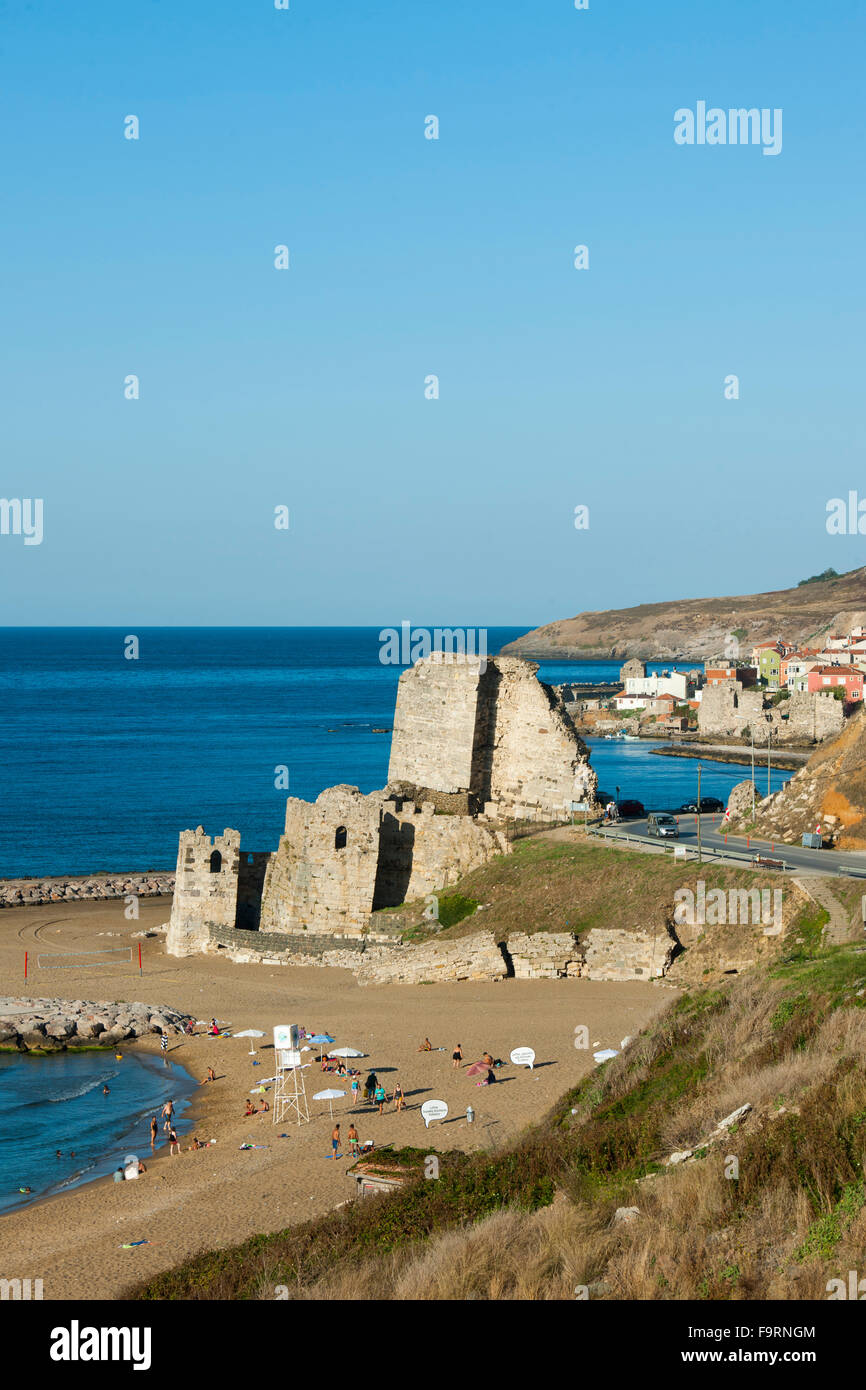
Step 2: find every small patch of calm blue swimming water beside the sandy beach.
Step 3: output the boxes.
[0,1047,197,1212]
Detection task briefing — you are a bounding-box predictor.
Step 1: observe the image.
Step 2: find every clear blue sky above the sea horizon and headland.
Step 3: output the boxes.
[0,0,866,627]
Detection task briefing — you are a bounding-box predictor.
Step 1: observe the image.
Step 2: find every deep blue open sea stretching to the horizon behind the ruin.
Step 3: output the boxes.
[0,627,791,877]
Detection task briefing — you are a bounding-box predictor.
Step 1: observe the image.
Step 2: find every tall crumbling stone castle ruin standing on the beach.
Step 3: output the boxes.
[167,653,596,955]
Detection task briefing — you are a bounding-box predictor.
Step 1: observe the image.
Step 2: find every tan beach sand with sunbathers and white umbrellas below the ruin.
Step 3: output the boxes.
[0,898,673,1300]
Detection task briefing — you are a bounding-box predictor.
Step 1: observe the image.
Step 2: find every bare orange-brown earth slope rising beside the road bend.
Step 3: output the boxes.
[735,710,866,849]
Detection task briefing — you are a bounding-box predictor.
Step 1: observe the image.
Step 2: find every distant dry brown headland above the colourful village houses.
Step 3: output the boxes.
[503,569,866,660]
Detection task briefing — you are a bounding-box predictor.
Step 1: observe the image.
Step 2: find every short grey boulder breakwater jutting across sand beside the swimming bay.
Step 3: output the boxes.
[0,997,188,1052]
